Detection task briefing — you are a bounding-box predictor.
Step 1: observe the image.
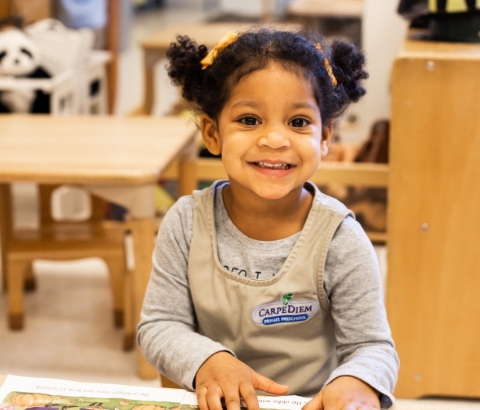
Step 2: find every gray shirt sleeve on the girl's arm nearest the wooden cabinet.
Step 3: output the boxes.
[324,218,399,407]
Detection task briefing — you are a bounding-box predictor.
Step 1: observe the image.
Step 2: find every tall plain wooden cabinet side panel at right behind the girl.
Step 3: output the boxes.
[387,34,480,398]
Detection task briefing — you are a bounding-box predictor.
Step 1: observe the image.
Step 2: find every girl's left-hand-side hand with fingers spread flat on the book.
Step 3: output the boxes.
[195,352,288,410]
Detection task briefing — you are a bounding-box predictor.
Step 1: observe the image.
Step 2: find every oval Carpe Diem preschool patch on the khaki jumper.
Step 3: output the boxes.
[252,293,318,326]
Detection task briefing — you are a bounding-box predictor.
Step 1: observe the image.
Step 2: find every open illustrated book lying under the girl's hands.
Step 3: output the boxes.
[0,375,311,410]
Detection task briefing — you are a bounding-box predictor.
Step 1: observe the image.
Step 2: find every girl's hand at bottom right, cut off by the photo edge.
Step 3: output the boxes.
[302,376,380,410]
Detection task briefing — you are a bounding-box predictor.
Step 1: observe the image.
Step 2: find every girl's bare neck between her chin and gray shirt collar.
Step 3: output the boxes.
[223,182,313,241]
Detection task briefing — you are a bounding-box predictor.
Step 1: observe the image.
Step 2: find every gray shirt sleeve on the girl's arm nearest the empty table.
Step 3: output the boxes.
[138,196,233,389]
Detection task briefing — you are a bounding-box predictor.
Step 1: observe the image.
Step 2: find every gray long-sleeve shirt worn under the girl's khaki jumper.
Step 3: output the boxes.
[138,185,398,407]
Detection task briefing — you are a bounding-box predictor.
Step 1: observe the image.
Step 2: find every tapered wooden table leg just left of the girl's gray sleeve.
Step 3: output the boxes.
[130,218,158,380]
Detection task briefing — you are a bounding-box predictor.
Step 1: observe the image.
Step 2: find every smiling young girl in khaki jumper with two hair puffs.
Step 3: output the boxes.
[138,28,398,410]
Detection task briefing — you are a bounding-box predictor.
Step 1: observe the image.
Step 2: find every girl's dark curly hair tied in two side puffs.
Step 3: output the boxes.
[167,28,368,124]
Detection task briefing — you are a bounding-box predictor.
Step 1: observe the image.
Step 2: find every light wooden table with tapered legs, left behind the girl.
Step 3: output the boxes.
[0,115,196,378]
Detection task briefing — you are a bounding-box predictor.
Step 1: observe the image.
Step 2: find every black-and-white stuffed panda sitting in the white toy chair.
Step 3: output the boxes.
[0,27,51,113]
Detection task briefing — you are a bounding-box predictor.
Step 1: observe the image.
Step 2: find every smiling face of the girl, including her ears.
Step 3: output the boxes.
[201,64,332,199]
